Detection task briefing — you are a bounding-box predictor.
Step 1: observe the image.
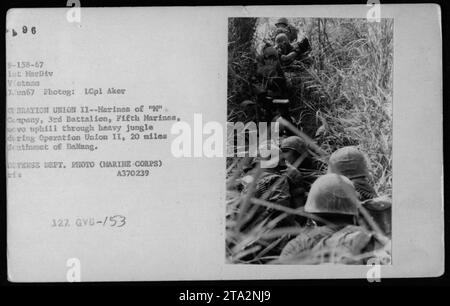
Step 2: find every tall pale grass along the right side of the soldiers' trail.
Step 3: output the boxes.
[303,19,393,195]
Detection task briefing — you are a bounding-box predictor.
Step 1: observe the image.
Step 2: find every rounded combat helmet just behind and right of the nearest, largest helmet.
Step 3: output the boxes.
[328,146,369,179]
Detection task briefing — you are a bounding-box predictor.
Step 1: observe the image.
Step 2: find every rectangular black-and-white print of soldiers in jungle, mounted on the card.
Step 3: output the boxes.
[226,17,394,265]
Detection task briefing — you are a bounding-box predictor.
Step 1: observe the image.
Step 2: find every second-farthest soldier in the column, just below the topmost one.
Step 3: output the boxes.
[275,32,311,66]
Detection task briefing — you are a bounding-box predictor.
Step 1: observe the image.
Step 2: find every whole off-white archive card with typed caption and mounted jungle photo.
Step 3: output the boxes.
[4,1,446,284]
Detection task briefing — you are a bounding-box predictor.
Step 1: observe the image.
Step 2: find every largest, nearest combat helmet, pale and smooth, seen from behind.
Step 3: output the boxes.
[305,173,359,216]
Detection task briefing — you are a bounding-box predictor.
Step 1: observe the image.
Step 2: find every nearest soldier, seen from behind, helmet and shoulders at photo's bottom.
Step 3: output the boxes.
[279,173,390,264]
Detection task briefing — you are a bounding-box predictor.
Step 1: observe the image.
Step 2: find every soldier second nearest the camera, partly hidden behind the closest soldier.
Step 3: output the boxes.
[328,146,392,236]
